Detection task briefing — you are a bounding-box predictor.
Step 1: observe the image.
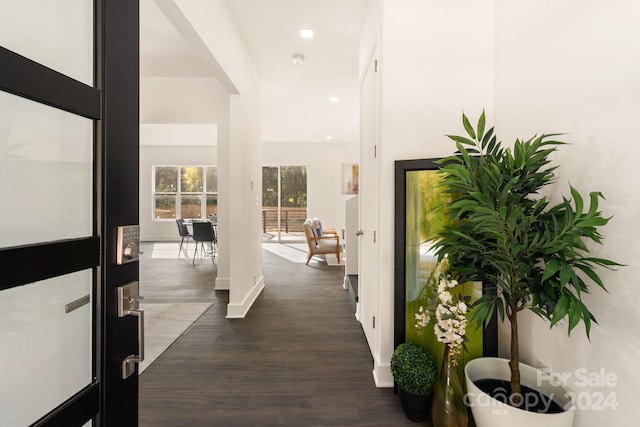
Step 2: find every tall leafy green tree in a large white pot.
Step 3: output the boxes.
[433,112,619,427]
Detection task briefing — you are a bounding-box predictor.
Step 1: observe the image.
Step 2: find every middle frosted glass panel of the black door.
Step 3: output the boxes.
[0,92,93,247]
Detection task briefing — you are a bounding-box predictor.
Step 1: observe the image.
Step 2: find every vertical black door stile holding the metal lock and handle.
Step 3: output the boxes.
[96,0,140,427]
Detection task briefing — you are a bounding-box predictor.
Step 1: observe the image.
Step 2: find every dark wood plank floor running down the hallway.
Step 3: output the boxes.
[139,246,429,427]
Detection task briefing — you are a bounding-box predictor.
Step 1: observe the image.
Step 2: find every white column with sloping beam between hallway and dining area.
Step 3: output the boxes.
[175,0,264,318]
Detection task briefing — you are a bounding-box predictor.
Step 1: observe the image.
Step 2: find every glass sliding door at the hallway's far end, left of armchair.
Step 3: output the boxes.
[262,166,307,242]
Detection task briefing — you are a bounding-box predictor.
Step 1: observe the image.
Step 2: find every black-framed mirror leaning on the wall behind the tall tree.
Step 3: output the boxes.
[394,158,498,361]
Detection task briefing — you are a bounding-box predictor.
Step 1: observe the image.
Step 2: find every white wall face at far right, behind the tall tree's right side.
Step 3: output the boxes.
[492,0,640,427]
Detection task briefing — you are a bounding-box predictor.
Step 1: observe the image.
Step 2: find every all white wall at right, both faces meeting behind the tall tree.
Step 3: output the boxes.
[362,0,640,427]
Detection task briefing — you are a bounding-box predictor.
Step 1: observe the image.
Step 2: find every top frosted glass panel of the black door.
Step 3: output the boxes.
[0,0,93,86]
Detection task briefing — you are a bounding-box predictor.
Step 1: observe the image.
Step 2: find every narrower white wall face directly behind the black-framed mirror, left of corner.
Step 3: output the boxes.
[361,0,494,386]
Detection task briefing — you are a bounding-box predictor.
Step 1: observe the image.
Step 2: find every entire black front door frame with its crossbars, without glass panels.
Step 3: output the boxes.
[0,0,139,427]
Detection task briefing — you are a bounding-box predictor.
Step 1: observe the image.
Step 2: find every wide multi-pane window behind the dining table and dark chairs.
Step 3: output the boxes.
[153,166,218,220]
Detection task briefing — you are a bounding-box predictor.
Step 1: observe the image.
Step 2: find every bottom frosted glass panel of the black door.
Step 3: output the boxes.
[0,270,93,426]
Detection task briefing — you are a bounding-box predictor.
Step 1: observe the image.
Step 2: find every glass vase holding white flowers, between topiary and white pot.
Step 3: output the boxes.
[431,345,469,427]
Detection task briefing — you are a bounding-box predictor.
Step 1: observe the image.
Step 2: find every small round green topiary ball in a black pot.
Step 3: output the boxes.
[391,342,438,422]
